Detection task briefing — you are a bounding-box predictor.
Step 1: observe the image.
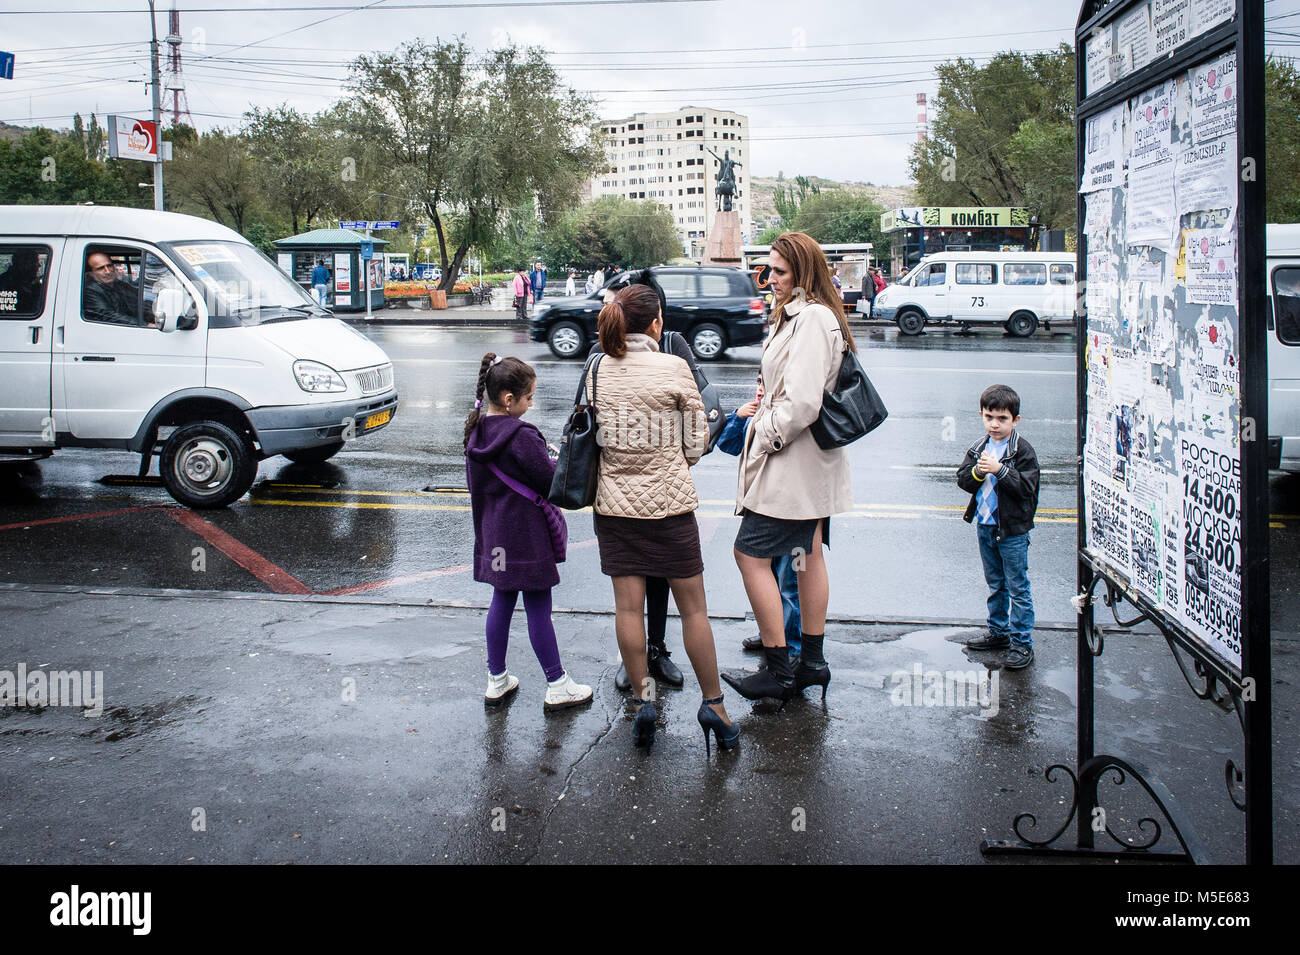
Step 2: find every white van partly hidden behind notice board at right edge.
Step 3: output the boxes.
[1265,223,1300,472]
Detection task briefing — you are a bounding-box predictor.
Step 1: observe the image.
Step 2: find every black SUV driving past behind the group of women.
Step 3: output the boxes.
[529,266,767,361]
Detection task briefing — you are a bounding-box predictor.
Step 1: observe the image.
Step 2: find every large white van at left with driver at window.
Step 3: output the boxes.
[0,205,398,508]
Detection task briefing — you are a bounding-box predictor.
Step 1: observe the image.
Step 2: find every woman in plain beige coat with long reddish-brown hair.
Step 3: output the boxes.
[723,233,857,703]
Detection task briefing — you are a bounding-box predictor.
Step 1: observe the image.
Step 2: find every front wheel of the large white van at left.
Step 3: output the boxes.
[159,421,257,509]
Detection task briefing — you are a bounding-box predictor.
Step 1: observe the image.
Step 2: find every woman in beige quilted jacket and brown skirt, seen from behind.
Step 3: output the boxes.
[588,285,740,751]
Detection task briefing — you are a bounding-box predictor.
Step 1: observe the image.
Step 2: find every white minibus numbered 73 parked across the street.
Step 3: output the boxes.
[858,252,1075,337]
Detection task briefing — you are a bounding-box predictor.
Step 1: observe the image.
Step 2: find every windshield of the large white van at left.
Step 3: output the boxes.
[164,242,329,329]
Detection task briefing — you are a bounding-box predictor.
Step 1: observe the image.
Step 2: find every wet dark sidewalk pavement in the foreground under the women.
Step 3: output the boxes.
[0,586,1300,864]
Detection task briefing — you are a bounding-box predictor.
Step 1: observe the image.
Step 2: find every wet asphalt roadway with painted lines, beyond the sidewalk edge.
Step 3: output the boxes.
[0,326,1300,624]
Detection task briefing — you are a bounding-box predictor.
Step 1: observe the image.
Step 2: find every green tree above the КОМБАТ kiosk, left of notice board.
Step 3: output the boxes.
[911,43,1076,229]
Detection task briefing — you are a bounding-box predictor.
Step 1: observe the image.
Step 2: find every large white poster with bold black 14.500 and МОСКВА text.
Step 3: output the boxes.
[1178,434,1242,667]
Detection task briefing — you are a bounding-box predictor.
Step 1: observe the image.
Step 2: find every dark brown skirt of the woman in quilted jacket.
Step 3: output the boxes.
[592,511,705,579]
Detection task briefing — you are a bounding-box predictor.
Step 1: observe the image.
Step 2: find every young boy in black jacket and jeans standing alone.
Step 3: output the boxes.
[957,385,1039,670]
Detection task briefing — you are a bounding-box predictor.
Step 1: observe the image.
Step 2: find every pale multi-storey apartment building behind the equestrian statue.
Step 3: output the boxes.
[590,107,751,256]
